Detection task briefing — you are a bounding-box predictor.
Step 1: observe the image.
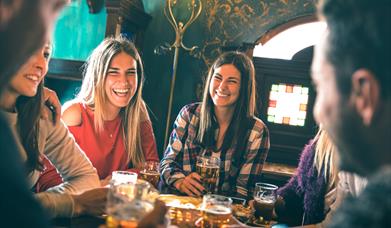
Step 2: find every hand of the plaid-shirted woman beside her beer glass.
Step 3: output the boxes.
[174,172,205,196]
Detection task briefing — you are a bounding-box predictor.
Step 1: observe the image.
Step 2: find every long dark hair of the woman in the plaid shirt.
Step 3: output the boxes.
[197,51,256,151]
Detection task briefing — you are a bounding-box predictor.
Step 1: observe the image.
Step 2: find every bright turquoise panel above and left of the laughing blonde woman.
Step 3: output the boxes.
[53,0,107,60]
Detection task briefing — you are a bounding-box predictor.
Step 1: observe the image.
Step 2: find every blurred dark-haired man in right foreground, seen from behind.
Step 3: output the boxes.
[312,0,391,227]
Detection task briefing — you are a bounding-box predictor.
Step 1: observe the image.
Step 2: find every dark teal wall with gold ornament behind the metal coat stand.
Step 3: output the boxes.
[142,0,316,153]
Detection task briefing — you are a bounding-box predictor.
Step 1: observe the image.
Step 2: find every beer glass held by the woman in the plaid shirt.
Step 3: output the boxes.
[196,156,220,193]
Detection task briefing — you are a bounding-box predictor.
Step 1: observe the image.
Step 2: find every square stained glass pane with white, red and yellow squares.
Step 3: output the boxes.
[267,83,308,126]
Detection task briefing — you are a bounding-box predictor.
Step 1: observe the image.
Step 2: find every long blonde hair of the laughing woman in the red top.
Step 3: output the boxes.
[76,36,146,168]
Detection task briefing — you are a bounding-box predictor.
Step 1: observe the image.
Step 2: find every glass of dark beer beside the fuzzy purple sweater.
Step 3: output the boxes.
[254,183,278,225]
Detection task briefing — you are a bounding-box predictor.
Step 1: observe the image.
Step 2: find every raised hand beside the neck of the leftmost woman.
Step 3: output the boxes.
[41,87,61,125]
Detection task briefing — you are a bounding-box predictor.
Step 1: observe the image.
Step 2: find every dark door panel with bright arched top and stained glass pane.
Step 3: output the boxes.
[253,19,326,166]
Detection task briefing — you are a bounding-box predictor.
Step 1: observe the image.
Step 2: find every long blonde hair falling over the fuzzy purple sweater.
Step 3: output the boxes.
[314,128,338,187]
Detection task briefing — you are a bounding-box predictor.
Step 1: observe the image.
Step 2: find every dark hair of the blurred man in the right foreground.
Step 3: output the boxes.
[321,0,391,98]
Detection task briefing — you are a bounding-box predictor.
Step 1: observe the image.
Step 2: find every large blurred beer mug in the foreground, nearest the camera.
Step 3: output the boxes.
[106,179,154,228]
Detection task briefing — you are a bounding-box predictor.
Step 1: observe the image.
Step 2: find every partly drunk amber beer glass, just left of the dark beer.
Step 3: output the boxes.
[201,194,232,228]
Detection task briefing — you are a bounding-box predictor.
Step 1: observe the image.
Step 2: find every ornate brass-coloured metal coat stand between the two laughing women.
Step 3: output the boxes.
[155,0,202,148]
